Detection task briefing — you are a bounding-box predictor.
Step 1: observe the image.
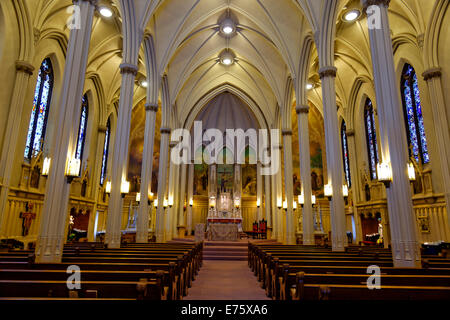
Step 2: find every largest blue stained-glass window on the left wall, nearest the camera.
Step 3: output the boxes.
[24,58,53,159]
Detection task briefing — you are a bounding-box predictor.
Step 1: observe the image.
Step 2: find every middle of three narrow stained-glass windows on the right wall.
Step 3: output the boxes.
[364,98,378,180]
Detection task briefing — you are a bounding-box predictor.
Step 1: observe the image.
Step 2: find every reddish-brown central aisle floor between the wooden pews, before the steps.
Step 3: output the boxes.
[184,260,269,300]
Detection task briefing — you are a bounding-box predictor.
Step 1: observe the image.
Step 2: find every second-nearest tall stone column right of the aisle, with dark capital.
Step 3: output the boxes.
[319,66,347,251]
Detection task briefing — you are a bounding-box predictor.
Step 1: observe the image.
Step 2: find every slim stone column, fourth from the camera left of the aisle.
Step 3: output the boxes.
[156,128,170,242]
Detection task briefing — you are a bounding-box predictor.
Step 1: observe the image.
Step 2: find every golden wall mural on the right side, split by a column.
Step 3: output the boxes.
[292,106,326,195]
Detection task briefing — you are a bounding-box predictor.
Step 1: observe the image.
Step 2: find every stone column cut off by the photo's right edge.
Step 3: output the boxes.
[423,67,450,226]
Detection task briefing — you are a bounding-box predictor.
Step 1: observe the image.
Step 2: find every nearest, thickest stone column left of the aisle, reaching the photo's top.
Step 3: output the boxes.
[36,0,96,263]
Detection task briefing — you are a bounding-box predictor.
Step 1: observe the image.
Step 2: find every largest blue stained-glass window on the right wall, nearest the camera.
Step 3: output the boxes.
[401,64,430,163]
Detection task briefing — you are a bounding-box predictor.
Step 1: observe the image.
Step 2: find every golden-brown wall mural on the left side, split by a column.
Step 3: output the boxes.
[128,100,161,194]
